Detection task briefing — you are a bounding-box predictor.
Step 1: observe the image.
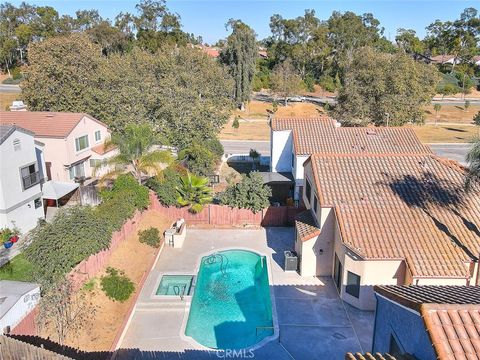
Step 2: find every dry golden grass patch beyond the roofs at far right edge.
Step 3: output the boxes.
[413,124,479,143]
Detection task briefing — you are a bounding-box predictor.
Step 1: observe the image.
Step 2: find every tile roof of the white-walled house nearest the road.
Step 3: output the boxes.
[271,116,432,155]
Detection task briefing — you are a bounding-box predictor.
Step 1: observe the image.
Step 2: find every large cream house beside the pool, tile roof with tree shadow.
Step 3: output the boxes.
[295,153,480,310]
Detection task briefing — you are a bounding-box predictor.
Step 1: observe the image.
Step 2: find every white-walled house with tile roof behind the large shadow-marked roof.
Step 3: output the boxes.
[270,116,432,200]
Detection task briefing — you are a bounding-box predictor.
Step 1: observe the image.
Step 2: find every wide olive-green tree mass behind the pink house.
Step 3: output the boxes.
[22,34,233,148]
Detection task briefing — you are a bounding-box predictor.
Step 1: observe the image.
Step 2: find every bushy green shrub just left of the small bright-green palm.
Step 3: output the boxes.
[146,165,185,206]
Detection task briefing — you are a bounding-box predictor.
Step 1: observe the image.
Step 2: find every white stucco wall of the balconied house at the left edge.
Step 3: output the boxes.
[0,130,44,233]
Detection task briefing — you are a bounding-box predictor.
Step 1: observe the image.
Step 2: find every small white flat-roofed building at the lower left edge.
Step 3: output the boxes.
[0,280,40,334]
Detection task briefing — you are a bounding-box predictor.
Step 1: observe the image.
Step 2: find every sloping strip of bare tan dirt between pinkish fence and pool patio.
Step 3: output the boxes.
[43,211,170,351]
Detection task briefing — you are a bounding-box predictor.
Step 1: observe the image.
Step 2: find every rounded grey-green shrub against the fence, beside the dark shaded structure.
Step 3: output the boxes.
[219,172,272,213]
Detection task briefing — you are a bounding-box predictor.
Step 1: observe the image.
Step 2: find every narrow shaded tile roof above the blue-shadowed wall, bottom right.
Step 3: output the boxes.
[374,285,480,311]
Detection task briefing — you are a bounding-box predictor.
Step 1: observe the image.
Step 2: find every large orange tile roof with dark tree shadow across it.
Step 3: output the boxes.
[307,154,480,278]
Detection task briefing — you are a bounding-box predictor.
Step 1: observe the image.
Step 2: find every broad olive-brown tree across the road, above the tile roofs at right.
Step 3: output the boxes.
[336,47,439,126]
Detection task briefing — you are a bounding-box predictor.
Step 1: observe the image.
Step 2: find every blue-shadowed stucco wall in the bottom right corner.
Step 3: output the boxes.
[372,294,437,360]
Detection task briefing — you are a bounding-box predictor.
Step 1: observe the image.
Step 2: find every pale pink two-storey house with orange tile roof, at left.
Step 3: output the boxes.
[0,111,114,182]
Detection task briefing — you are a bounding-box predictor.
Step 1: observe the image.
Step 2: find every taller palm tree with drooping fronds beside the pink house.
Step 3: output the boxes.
[99,124,173,184]
